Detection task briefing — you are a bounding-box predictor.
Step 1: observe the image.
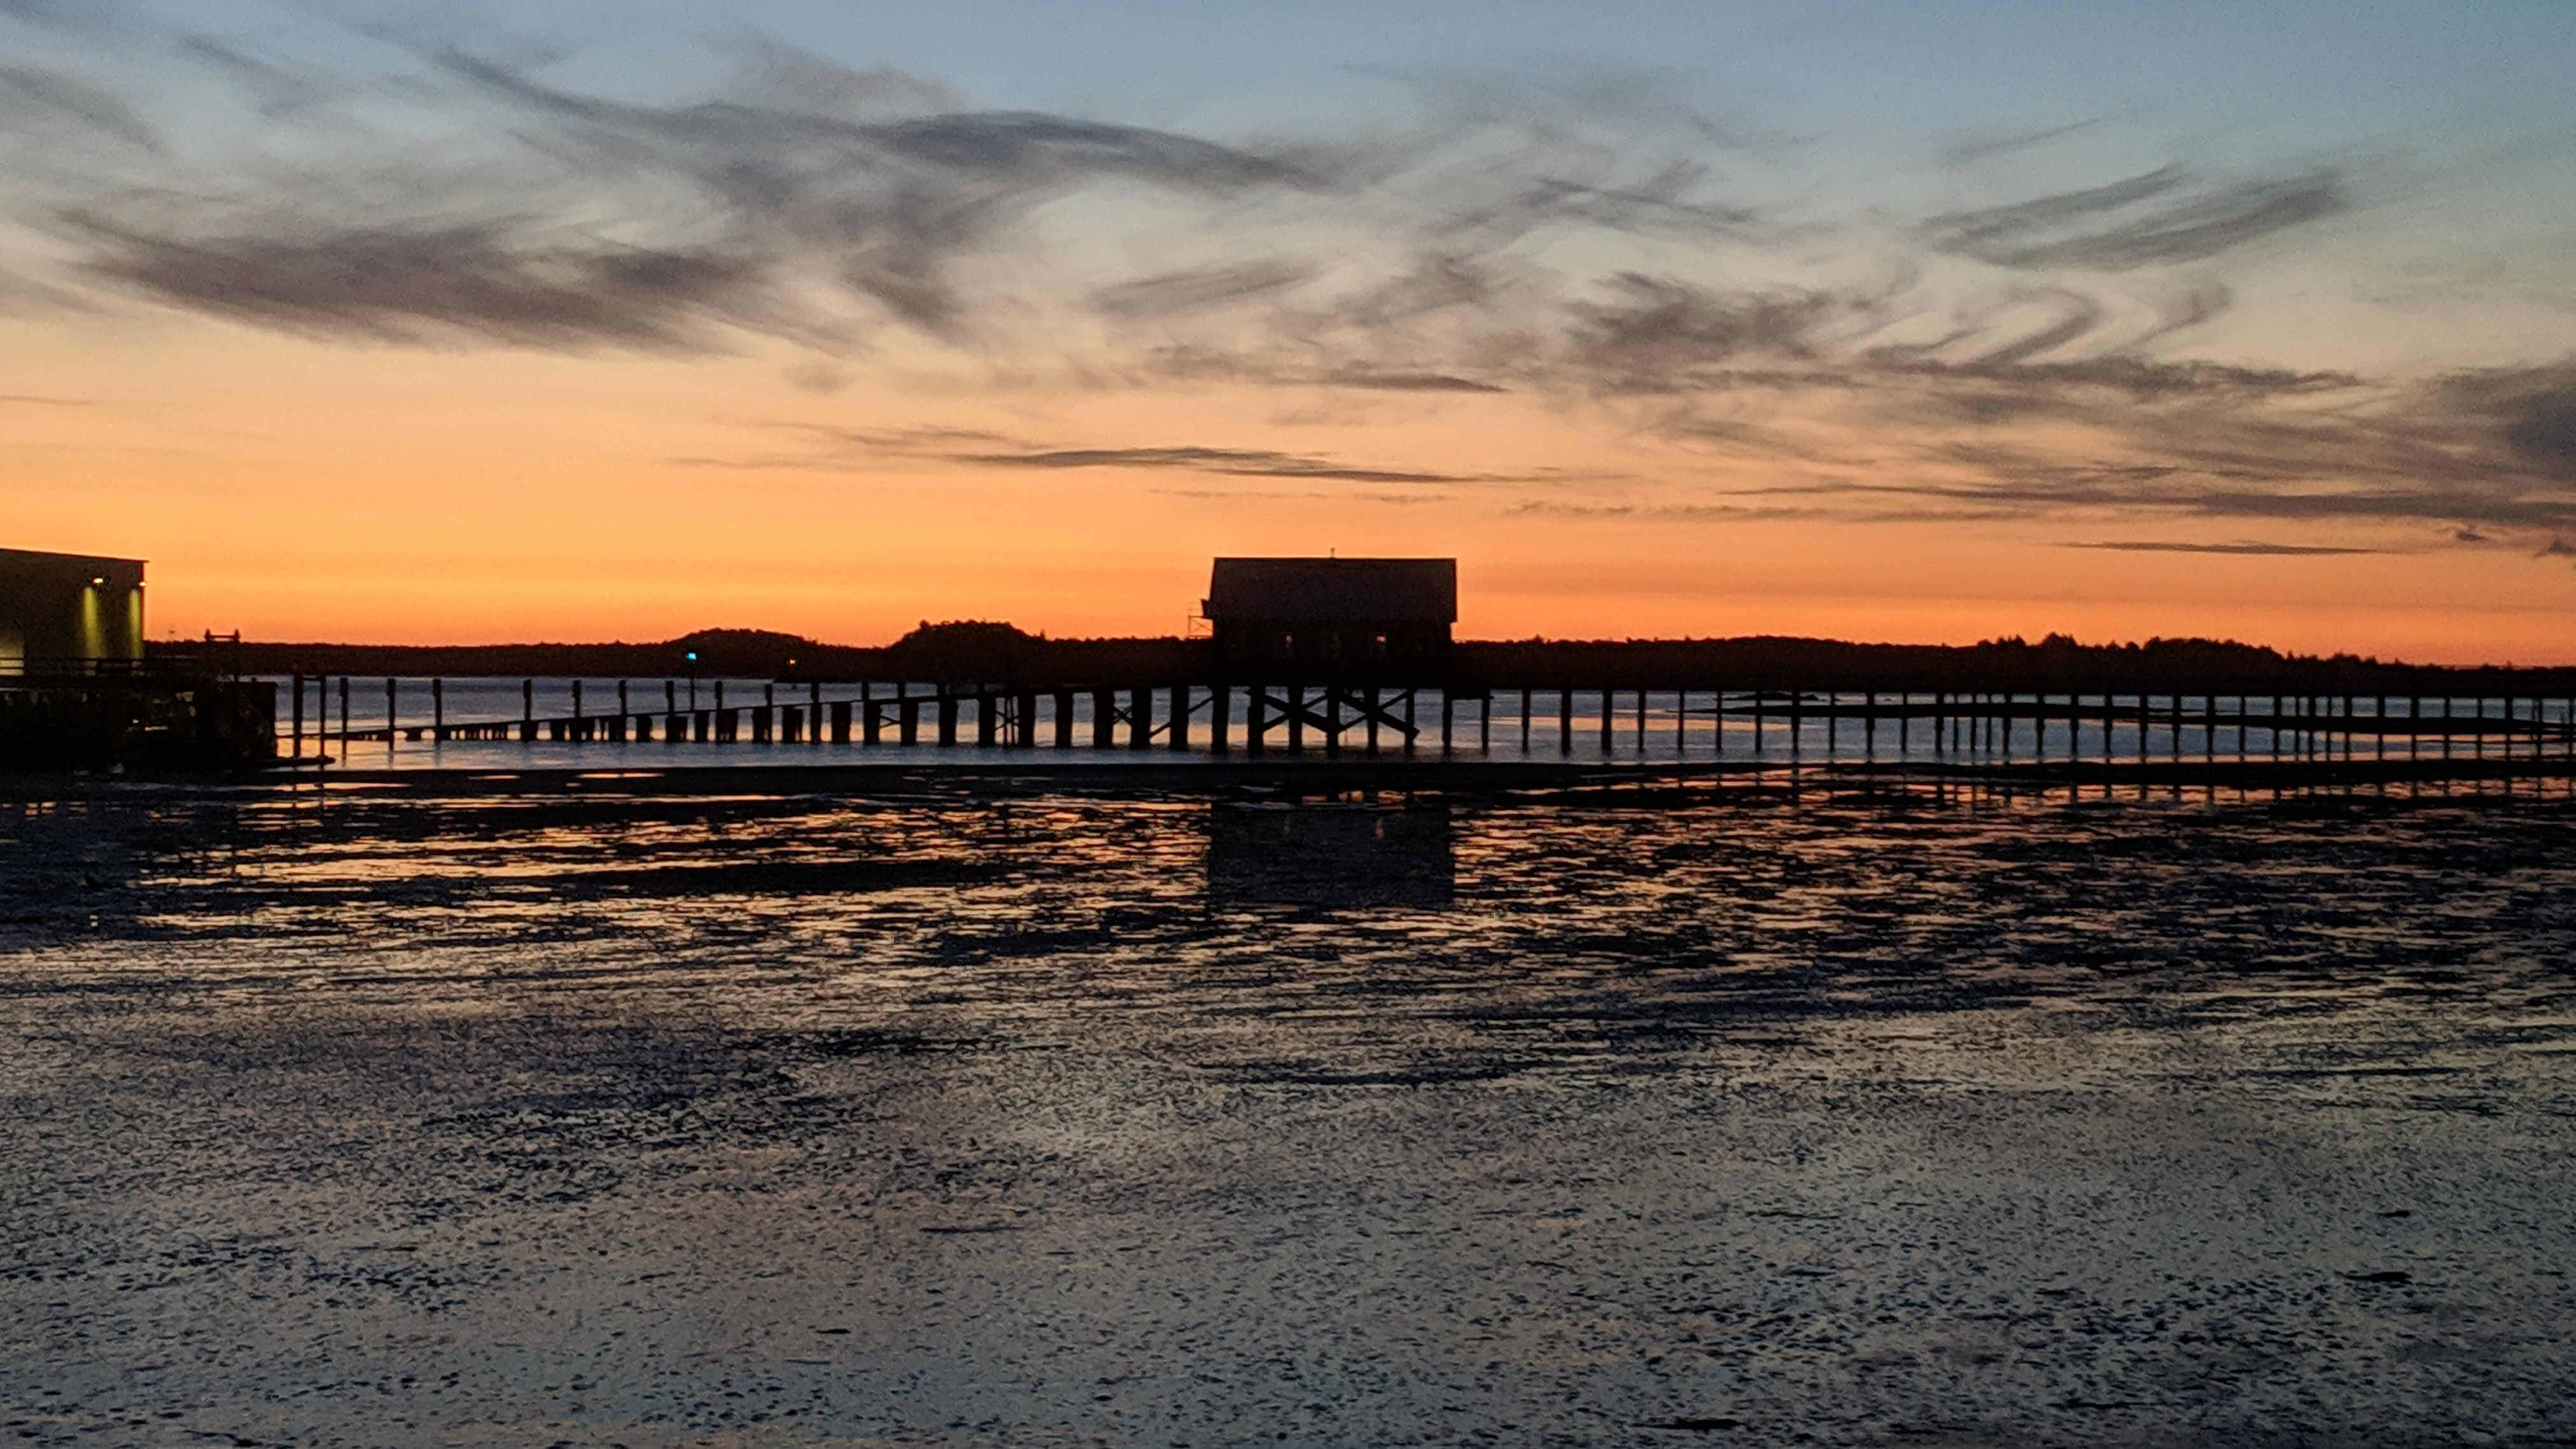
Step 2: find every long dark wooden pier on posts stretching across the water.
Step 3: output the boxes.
[281,676,2576,766]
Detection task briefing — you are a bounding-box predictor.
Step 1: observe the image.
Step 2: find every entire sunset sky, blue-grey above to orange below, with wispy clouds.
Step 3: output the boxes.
[0,0,2576,662]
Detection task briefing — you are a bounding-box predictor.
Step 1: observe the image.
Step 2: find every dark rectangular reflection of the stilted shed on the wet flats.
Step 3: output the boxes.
[1208,799,1458,907]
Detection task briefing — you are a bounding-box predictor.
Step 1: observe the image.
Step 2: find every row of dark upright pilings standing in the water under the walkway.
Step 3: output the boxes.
[347,670,2576,766]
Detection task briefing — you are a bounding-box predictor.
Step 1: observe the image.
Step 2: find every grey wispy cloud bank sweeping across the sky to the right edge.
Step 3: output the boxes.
[0,15,2576,564]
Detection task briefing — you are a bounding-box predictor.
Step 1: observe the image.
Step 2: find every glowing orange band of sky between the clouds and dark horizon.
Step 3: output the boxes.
[0,322,2576,662]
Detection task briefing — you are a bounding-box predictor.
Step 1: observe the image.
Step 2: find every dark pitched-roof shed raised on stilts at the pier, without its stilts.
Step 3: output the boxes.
[1200,559,1458,673]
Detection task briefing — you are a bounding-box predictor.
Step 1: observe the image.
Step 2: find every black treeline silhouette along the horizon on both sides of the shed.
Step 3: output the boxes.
[190,621,2576,699]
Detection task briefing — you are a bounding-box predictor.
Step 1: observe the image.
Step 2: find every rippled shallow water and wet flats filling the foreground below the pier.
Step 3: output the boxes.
[0,789,2576,1446]
